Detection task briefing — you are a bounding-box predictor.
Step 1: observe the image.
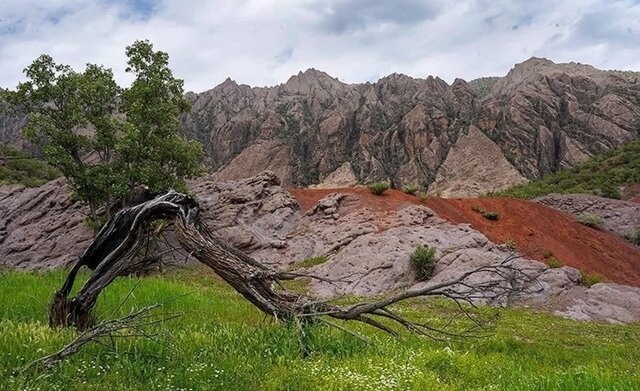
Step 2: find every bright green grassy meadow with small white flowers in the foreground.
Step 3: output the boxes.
[0,270,640,390]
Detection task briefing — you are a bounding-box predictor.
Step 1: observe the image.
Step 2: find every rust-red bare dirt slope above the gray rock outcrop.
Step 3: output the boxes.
[289,187,640,286]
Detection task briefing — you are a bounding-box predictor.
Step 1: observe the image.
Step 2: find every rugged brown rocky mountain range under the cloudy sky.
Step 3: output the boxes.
[183,58,640,196]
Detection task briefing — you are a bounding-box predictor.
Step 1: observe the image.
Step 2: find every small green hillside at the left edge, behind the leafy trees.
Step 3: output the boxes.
[0,145,60,187]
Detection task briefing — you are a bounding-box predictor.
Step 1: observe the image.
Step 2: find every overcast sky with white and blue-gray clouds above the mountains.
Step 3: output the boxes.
[0,0,640,91]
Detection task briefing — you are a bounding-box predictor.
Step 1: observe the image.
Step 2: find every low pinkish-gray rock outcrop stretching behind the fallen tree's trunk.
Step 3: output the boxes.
[0,172,640,322]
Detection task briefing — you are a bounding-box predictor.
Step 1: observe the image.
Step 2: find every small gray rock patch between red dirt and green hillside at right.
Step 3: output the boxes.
[536,194,640,243]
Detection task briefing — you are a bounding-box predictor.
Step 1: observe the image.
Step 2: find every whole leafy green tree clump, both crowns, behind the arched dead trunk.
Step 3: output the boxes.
[7,41,201,227]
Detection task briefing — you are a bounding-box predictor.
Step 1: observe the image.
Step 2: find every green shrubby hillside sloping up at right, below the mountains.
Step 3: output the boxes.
[489,140,640,199]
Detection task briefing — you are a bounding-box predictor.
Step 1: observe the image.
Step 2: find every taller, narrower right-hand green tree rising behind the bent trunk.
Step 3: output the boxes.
[119,41,202,191]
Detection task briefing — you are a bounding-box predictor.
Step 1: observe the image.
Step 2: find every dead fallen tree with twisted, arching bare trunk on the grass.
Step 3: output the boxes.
[50,191,530,337]
